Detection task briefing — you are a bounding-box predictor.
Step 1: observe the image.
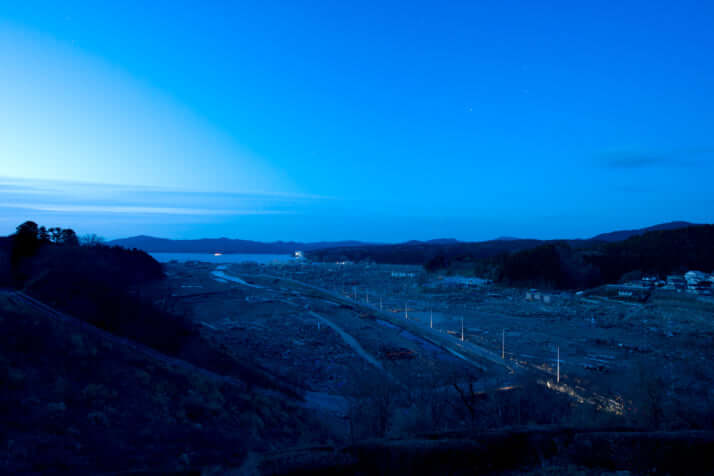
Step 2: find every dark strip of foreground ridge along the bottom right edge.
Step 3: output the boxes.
[255,427,714,475]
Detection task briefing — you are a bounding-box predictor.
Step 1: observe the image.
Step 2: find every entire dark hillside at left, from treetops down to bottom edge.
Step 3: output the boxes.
[0,222,320,474]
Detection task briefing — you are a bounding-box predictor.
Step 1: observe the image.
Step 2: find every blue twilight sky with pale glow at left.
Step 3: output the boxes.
[0,0,714,241]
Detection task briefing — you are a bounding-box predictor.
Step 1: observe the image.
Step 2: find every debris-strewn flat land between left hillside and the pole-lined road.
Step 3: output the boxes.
[165,264,496,395]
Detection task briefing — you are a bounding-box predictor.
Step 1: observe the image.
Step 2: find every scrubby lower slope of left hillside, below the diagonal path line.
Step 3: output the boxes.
[0,293,314,474]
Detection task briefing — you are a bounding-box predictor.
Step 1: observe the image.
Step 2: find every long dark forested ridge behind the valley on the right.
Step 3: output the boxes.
[308,222,714,289]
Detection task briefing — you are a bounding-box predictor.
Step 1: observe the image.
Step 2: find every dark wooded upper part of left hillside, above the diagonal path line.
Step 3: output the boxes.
[9,222,294,389]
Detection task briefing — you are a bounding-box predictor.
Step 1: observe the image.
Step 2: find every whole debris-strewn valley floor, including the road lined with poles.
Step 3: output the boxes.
[160,256,714,441]
